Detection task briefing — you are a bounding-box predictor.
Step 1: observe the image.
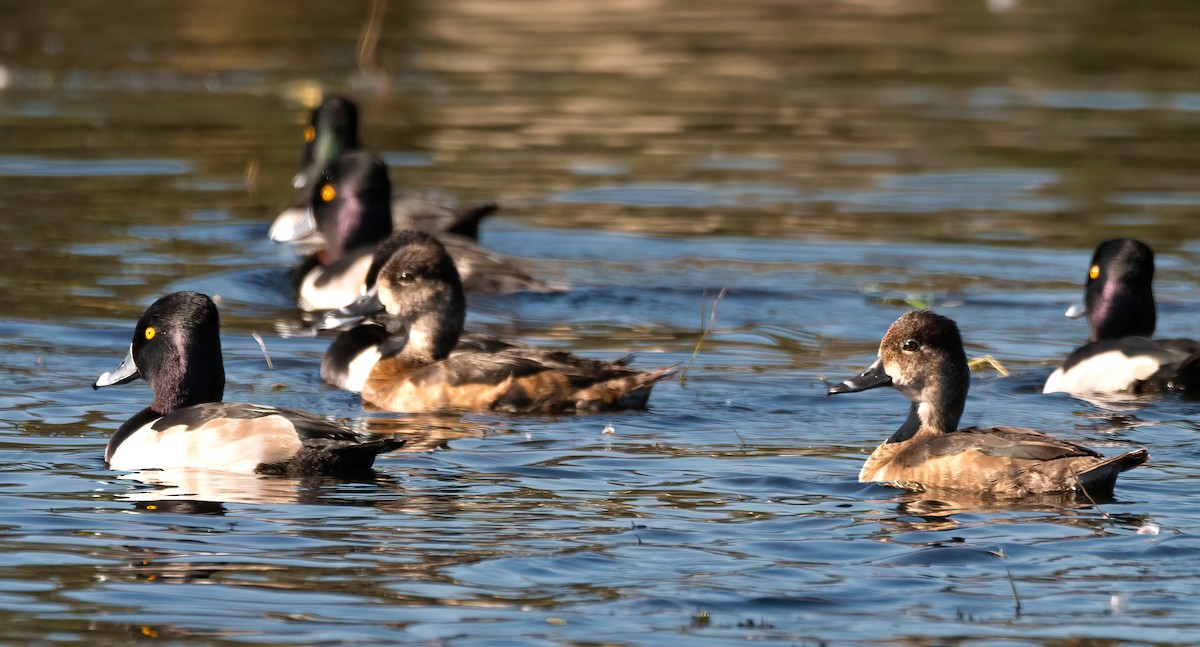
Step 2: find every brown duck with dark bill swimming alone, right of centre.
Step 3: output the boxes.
[828,310,1148,498]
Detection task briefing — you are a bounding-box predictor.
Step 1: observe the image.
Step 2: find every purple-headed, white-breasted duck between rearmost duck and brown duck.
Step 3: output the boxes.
[280,151,562,311]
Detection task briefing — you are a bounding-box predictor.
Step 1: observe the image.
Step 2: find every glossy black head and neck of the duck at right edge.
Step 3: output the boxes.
[1084,238,1157,341]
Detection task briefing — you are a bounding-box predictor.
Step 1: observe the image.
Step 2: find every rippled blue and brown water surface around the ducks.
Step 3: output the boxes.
[0,0,1200,646]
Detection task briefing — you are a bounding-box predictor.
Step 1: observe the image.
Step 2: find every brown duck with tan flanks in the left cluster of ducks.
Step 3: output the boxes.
[325,229,674,413]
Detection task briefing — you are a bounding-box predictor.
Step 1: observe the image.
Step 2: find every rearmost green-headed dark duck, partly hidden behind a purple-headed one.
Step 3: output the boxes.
[268,95,499,240]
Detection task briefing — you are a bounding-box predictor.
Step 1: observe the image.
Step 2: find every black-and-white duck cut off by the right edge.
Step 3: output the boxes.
[1042,238,1200,396]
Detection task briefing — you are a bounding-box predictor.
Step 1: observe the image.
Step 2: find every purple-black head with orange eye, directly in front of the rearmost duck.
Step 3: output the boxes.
[312,151,392,265]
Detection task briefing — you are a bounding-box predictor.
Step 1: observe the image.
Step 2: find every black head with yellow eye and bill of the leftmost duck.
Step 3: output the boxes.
[92,292,224,415]
